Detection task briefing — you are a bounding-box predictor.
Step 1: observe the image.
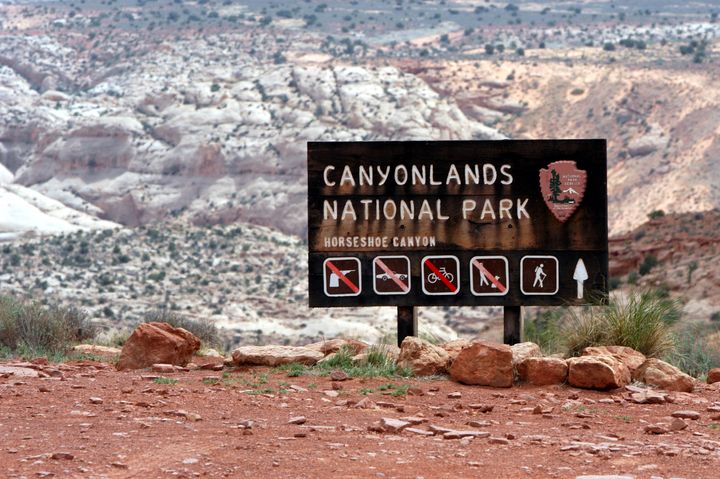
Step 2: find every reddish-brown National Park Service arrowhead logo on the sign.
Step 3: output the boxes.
[540,161,587,223]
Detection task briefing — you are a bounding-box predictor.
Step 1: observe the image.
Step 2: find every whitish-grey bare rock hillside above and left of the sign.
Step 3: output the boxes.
[0,30,503,240]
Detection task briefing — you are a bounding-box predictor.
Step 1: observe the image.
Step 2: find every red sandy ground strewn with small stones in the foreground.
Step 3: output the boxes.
[0,362,720,479]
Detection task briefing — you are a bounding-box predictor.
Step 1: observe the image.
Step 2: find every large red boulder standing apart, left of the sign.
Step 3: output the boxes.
[117,323,200,370]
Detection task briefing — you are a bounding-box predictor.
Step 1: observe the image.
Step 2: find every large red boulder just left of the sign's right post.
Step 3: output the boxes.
[450,341,513,388]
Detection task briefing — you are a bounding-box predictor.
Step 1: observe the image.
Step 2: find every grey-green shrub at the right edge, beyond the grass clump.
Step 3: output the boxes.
[664,324,720,378]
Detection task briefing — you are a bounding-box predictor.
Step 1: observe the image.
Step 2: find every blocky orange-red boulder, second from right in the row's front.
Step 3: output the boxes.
[567,356,630,390]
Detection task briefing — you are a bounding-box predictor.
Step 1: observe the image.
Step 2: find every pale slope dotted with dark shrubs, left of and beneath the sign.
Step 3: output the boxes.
[0,221,490,344]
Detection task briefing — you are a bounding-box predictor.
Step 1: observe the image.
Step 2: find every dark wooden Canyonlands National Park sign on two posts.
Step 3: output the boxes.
[308,140,608,343]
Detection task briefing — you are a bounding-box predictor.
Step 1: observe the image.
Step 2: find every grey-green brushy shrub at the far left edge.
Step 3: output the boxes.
[0,296,96,356]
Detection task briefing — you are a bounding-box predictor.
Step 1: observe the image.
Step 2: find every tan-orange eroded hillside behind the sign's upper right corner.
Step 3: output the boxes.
[401,50,720,234]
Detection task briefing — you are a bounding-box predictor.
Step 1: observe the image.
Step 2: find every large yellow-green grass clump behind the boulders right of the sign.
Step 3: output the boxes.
[563,291,680,357]
